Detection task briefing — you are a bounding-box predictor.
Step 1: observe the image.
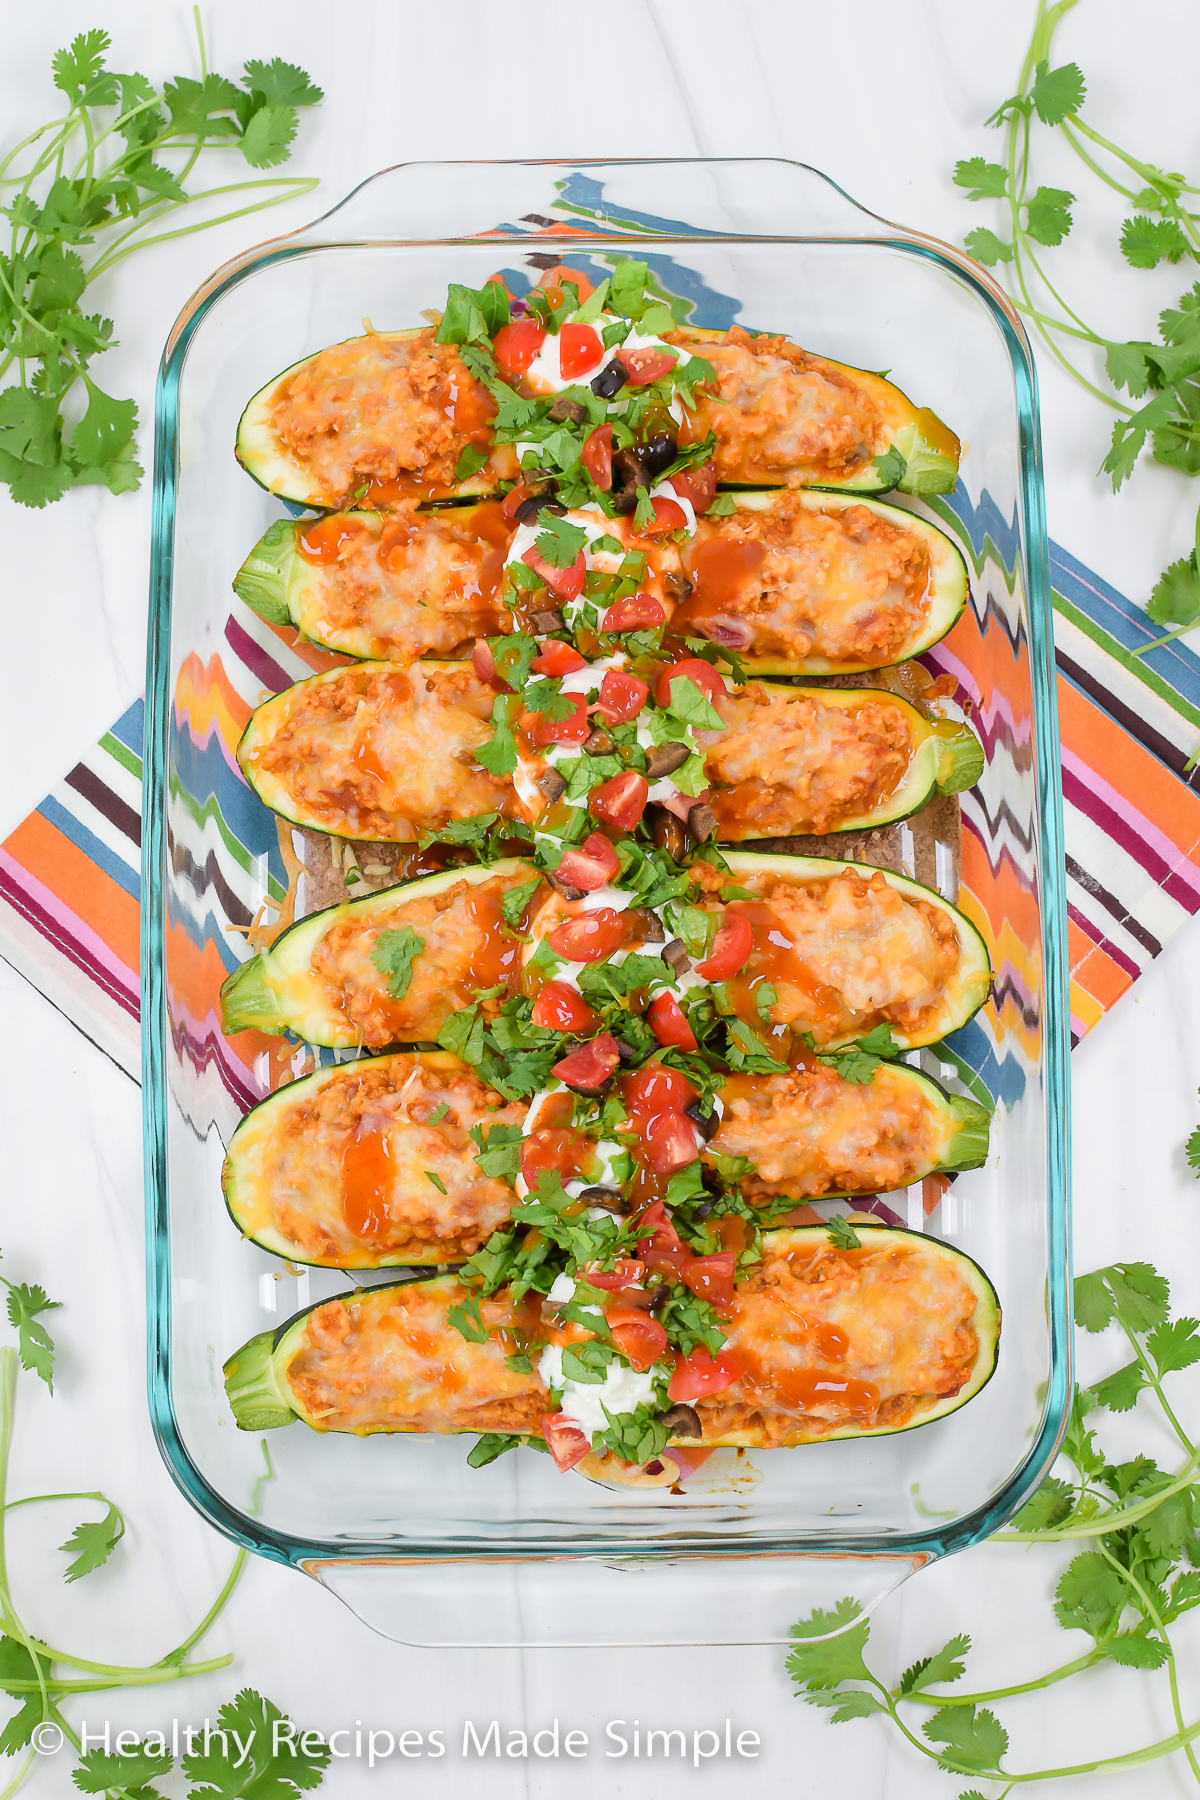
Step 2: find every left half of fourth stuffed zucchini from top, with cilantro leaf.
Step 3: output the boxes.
[221,859,545,1049]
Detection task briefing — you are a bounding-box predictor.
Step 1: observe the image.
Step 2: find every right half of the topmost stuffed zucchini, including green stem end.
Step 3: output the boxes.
[666,326,959,493]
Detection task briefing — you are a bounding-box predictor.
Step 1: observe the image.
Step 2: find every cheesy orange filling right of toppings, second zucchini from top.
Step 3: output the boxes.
[680,495,930,668]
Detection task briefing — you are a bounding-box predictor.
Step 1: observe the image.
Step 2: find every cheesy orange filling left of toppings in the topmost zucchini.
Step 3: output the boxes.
[268,329,497,497]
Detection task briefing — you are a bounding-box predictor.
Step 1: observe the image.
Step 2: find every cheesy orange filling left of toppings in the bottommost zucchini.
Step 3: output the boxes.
[286,1282,551,1435]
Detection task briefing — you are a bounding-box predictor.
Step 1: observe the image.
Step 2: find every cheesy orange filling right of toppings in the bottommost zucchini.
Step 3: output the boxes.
[693,1233,979,1447]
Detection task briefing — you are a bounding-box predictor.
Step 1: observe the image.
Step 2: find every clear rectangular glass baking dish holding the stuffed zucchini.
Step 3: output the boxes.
[142,160,1070,1643]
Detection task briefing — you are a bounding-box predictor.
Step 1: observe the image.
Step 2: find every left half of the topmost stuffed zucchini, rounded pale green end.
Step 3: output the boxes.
[234,326,518,508]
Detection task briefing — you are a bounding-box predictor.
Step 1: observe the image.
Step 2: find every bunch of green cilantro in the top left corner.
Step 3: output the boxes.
[0,22,322,506]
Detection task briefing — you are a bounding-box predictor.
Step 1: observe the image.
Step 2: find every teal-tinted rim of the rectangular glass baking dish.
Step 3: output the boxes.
[140,157,1072,1568]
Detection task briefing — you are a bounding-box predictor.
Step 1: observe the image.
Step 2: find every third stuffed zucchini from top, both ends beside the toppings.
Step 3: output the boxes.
[237,662,984,844]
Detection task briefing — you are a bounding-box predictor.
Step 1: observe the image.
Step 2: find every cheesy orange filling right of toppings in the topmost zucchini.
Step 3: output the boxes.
[667,326,885,482]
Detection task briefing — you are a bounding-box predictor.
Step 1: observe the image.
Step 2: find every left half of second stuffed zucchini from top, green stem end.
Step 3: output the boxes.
[234,500,516,662]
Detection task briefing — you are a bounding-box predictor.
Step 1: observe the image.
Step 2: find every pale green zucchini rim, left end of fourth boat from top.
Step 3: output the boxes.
[221,857,540,1049]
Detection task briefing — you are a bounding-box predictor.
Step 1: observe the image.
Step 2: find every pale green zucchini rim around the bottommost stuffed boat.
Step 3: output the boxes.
[223,1226,1002,1449]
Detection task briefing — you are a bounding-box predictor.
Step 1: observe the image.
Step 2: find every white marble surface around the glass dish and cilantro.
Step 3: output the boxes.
[0,0,1200,1800]
